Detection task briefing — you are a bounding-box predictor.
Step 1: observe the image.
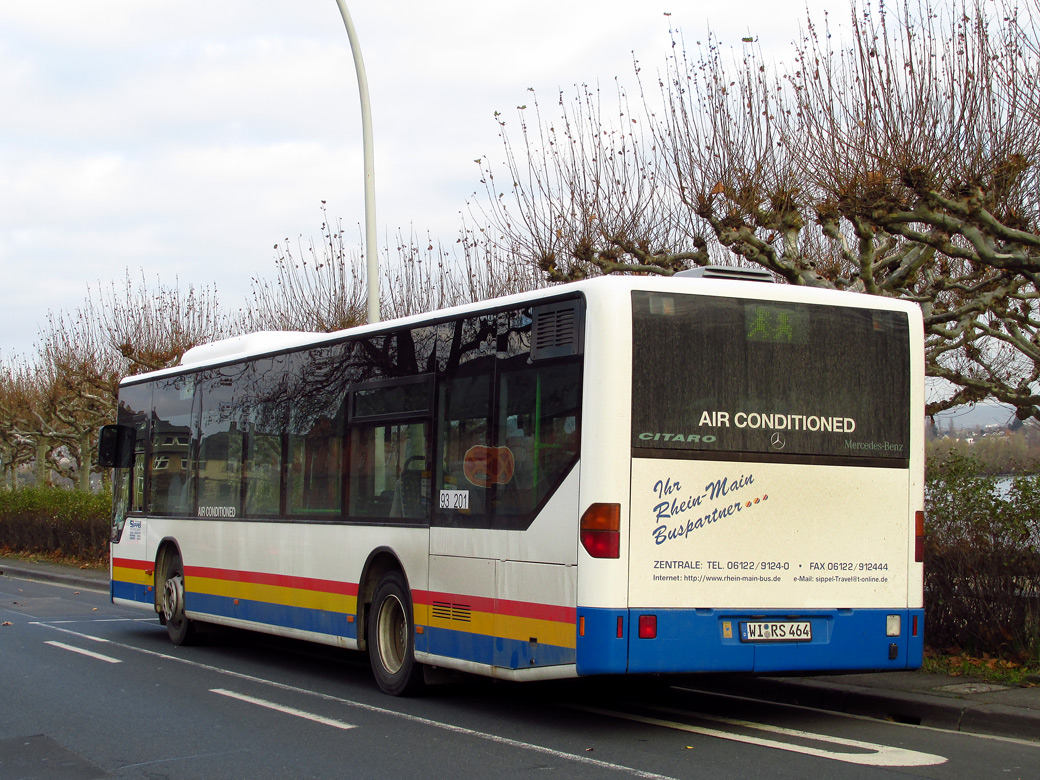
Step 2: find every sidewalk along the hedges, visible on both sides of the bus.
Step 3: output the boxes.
[0,557,1040,742]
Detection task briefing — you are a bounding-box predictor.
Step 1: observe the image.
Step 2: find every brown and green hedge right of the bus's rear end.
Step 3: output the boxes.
[925,452,1040,657]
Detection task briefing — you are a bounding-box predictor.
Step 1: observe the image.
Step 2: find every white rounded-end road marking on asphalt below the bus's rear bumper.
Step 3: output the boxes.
[569,704,946,766]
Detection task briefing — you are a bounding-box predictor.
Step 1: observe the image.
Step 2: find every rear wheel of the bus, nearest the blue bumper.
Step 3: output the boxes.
[368,571,423,696]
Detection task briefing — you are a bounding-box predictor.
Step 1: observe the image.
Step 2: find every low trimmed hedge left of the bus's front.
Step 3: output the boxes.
[0,487,112,561]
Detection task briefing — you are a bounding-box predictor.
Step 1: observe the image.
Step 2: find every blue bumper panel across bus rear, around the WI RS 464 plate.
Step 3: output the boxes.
[577,607,925,675]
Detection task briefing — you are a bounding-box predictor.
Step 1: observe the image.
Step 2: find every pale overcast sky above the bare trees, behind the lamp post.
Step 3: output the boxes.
[0,0,848,359]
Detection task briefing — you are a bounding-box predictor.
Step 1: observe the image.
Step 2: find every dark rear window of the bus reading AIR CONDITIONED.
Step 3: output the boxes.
[632,291,910,466]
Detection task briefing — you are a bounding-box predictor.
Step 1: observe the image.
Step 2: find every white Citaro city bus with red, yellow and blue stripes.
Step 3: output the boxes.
[100,268,925,695]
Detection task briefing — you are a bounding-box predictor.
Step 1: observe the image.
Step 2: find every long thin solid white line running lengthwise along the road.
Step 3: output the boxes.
[40,623,676,780]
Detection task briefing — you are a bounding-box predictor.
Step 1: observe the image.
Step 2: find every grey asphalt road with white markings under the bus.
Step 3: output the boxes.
[0,577,1040,780]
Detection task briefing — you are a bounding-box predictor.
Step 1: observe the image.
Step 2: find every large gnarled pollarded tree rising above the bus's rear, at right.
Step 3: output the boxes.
[478,0,1040,419]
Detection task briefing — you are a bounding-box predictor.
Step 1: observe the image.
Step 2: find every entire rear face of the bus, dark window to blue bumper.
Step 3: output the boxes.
[576,286,924,675]
